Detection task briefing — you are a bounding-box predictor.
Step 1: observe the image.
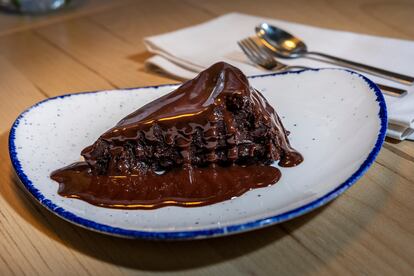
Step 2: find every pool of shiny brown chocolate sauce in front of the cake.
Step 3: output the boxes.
[52,162,281,209]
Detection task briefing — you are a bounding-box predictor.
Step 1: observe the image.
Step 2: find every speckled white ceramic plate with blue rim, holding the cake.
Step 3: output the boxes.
[9,69,387,239]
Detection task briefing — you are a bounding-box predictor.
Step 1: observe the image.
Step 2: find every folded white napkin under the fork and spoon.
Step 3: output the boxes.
[144,13,414,140]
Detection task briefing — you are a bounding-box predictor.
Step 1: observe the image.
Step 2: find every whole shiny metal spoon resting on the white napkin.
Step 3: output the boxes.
[256,23,414,85]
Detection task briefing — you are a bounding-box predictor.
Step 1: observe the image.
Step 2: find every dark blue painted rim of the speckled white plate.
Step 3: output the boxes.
[9,68,387,240]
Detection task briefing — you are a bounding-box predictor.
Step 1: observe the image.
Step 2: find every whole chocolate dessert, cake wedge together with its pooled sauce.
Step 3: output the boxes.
[52,62,303,209]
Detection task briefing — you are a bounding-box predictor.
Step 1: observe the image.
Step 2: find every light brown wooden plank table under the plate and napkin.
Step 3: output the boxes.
[0,0,414,275]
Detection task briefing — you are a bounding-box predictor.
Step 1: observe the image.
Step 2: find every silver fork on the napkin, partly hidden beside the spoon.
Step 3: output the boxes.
[237,37,407,97]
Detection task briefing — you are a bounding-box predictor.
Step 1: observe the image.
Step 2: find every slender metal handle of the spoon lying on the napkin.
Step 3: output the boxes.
[306,52,414,85]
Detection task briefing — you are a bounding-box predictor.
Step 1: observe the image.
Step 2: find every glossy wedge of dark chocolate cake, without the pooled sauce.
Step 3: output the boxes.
[82,62,302,175]
